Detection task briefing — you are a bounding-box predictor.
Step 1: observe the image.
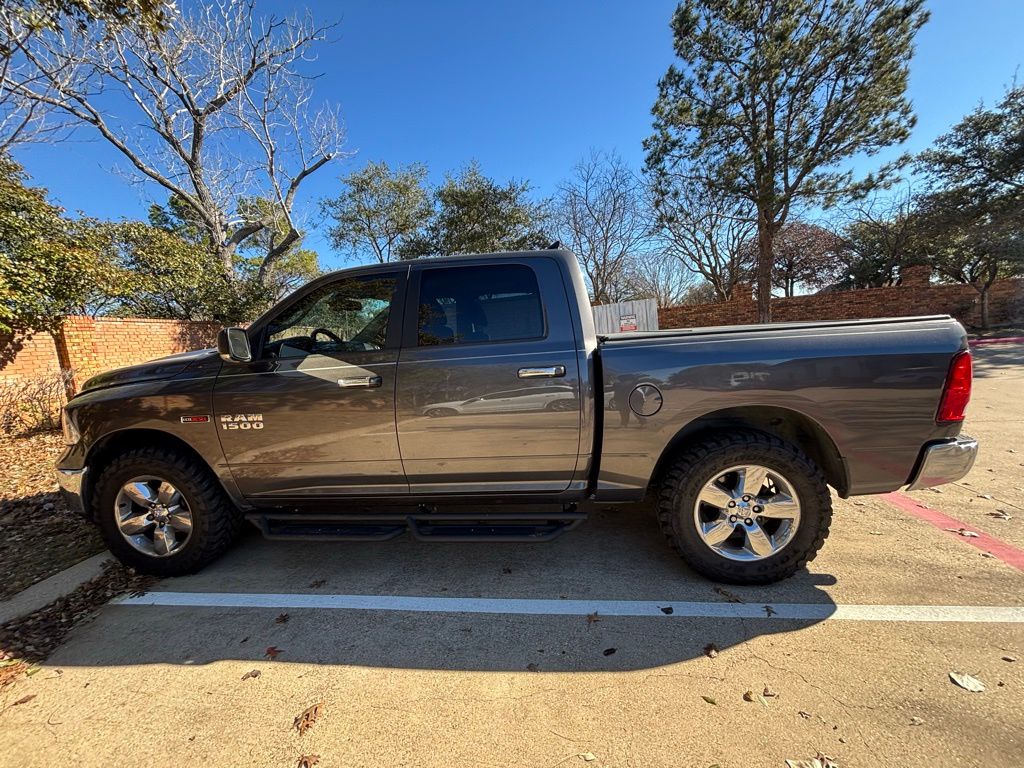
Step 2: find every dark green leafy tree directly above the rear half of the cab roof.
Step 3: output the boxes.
[399,163,551,258]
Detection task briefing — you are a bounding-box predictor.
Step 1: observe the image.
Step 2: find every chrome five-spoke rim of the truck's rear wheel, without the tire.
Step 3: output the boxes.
[693,464,800,561]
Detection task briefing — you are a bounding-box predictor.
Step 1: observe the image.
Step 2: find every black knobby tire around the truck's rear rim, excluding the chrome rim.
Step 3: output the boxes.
[657,430,831,585]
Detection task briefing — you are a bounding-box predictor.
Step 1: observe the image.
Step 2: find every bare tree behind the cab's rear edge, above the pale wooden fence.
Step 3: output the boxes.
[554,152,652,303]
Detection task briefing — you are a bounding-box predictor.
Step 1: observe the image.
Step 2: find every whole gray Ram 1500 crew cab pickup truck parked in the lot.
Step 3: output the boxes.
[57,250,977,584]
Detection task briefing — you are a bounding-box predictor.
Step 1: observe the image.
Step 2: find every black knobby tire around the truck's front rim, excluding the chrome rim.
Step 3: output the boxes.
[92,446,242,577]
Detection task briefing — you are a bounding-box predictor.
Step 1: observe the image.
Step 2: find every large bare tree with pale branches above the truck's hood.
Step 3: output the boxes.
[0,0,343,284]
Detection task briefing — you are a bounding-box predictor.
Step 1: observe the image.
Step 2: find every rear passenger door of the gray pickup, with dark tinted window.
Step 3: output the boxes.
[396,257,583,494]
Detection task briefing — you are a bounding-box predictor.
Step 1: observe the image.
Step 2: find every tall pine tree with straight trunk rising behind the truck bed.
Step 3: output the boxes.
[645,0,928,322]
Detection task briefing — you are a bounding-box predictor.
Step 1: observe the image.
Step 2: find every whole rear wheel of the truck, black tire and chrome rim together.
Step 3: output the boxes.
[657,430,831,585]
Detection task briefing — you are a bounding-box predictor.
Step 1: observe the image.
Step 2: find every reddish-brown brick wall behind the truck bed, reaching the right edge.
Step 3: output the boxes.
[658,267,1024,328]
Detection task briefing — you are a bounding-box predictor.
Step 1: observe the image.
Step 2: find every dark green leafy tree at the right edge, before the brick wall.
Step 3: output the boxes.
[916,86,1024,328]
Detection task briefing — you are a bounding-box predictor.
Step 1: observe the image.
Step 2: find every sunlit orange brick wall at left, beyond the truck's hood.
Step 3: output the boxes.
[0,317,220,388]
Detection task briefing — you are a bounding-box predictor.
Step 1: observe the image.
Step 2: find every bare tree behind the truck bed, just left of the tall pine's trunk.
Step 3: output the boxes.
[654,182,757,301]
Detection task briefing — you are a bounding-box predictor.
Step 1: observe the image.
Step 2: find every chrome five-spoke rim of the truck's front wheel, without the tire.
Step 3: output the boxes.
[114,475,193,557]
